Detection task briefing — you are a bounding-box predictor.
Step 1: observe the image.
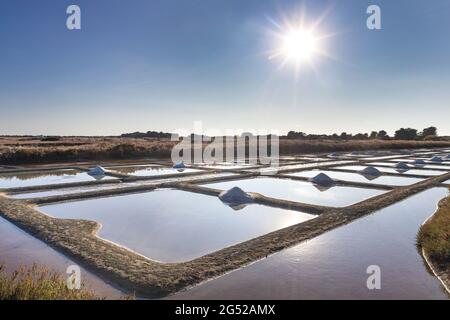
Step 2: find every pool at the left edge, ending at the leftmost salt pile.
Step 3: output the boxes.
[0,170,113,189]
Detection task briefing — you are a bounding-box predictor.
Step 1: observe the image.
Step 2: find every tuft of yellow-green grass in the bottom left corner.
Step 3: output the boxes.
[0,265,100,300]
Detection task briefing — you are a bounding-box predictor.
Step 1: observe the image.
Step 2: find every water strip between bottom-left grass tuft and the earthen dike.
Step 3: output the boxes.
[0,217,125,299]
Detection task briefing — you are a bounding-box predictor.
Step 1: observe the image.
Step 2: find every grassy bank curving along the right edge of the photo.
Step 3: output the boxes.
[417,190,450,294]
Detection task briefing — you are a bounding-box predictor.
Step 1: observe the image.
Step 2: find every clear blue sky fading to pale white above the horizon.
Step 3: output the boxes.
[0,0,450,135]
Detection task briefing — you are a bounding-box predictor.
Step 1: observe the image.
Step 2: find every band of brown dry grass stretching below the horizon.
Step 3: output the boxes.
[0,137,450,165]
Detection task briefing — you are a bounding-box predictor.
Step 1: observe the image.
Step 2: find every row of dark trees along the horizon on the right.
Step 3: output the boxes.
[286,127,438,140]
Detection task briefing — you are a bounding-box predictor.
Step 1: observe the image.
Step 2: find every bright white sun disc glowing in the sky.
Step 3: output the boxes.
[280,28,318,64]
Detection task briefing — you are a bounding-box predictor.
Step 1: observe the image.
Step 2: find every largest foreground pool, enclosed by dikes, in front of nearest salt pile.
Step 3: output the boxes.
[40,190,315,262]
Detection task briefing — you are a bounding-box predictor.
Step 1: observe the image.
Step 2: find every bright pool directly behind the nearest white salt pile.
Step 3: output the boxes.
[204,178,383,207]
